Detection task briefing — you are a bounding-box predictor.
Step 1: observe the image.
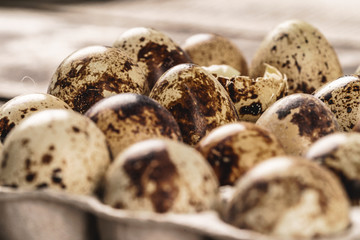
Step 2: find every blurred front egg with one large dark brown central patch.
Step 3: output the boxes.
[104,139,218,213]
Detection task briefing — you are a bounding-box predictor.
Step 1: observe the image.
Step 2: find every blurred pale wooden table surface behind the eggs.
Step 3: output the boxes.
[0,0,360,100]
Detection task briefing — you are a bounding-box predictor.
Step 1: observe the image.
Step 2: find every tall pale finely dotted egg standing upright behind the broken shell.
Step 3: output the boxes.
[250,20,343,93]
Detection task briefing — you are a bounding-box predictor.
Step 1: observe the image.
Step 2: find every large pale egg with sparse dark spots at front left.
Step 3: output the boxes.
[0,109,110,194]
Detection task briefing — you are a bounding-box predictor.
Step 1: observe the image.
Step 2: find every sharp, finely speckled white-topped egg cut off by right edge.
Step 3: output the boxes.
[314,75,360,131]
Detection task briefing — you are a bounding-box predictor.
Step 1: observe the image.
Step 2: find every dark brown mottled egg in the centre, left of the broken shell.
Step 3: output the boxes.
[149,64,238,145]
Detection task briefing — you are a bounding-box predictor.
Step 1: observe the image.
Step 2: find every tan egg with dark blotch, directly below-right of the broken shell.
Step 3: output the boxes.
[256,93,340,156]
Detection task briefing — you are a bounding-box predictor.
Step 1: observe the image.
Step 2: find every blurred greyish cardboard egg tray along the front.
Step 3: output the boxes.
[0,187,360,240]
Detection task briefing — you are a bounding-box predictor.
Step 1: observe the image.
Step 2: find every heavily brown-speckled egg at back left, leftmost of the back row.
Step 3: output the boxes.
[48,46,149,113]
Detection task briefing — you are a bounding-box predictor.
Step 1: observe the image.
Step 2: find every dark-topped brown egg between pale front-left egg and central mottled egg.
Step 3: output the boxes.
[85,93,182,157]
